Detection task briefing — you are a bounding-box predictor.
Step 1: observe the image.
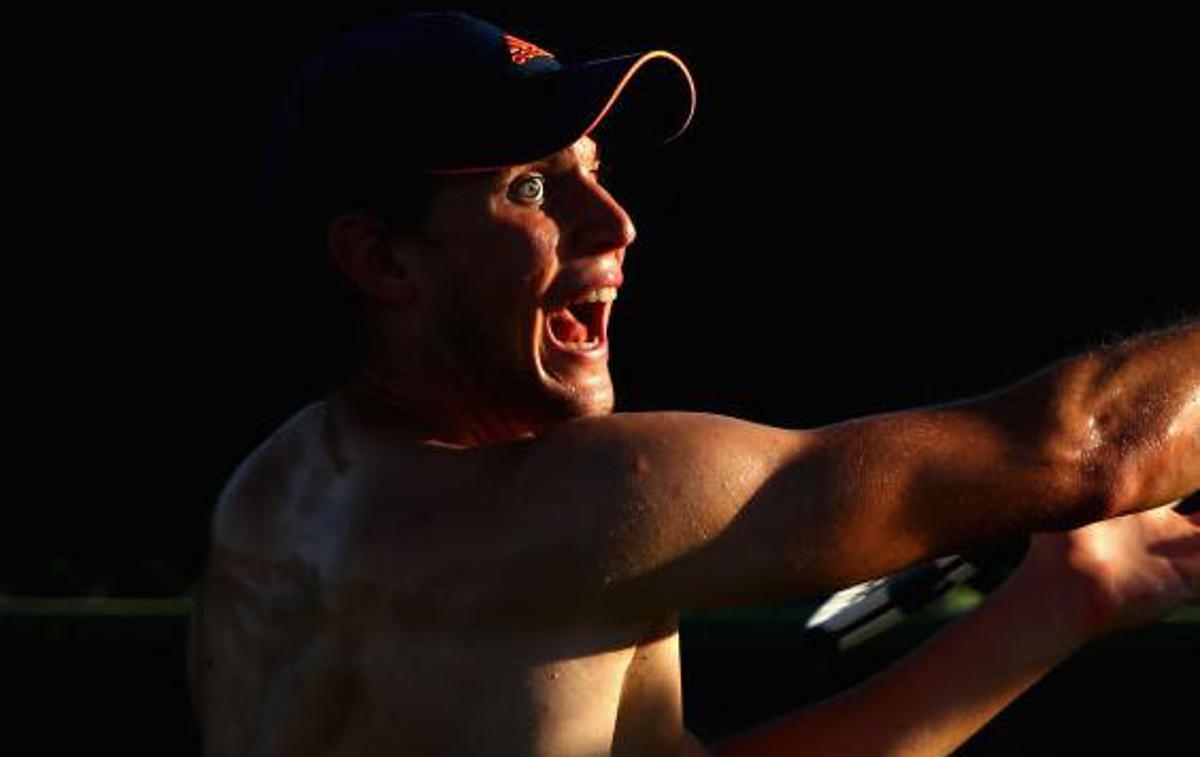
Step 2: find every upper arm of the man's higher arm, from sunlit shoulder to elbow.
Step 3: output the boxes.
[511,403,1094,615]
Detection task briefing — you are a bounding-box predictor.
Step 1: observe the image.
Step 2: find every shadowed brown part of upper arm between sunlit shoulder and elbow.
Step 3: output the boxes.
[676,397,1098,602]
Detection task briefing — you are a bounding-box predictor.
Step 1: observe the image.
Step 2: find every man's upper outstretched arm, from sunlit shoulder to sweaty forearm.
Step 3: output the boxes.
[494,322,1200,617]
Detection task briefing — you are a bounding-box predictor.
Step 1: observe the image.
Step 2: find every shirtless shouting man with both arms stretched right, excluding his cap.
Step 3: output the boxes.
[188,16,1200,756]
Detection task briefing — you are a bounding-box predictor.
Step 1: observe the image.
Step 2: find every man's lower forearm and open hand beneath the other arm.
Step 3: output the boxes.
[718,496,1200,756]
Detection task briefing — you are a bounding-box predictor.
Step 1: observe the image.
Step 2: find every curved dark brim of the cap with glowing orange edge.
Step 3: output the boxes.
[428,50,696,174]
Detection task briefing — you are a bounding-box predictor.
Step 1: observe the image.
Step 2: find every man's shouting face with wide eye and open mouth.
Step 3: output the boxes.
[412,137,635,427]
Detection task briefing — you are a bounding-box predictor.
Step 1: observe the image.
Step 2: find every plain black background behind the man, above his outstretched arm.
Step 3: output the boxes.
[11,4,1198,753]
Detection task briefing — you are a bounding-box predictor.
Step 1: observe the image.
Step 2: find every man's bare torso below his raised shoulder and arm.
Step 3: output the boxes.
[198,400,696,755]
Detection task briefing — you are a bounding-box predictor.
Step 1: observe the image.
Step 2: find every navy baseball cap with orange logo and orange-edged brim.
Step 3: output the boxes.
[262,12,696,179]
